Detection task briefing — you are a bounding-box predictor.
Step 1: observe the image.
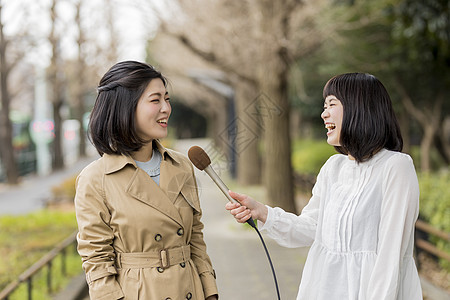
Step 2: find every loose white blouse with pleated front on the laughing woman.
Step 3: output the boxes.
[261,149,422,300]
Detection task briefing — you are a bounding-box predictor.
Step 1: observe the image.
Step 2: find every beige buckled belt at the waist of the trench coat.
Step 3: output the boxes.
[116,245,191,269]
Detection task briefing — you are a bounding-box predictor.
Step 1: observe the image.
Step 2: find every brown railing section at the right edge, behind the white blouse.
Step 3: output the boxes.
[415,220,450,268]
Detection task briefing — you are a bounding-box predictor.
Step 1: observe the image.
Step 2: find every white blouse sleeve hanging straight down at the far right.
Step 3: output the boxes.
[367,154,419,300]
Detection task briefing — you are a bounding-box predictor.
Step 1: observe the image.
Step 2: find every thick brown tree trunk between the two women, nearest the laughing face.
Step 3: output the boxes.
[256,1,296,213]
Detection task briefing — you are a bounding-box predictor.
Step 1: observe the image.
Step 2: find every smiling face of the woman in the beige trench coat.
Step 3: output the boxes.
[136,78,172,141]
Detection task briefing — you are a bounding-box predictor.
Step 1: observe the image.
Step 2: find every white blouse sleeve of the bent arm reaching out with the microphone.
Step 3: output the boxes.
[260,168,324,248]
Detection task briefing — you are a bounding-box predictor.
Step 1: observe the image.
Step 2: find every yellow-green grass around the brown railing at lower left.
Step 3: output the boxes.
[0,209,82,300]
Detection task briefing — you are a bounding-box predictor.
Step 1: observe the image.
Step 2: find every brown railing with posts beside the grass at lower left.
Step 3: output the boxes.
[0,232,77,300]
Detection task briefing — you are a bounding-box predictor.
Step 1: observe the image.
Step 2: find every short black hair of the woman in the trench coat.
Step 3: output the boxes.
[89,61,167,156]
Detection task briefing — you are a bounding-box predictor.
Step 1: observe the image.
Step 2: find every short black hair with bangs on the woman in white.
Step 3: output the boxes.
[323,73,403,162]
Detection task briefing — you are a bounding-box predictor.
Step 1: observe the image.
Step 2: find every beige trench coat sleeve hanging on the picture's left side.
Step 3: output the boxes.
[75,168,124,300]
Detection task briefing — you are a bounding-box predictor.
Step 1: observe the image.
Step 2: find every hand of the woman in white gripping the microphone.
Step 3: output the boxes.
[225,191,267,223]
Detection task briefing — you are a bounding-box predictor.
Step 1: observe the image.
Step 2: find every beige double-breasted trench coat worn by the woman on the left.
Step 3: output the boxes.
[75,142,218,300]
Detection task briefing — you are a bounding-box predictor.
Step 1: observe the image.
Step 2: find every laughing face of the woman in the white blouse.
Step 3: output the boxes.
[320,95,344,146]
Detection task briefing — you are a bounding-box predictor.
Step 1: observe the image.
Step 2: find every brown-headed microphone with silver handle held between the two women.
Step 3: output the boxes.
[188,146,256,228]
